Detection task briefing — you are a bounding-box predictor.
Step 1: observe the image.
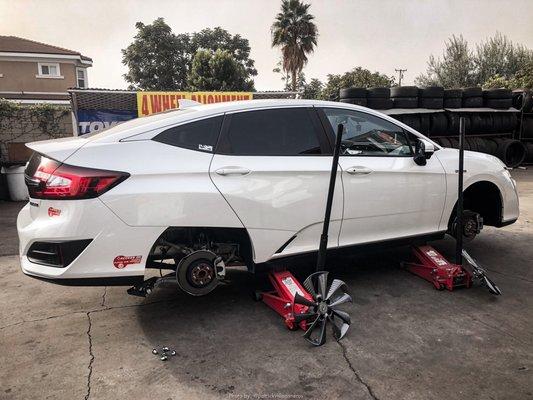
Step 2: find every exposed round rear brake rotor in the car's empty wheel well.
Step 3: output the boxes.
[176,250,219,296]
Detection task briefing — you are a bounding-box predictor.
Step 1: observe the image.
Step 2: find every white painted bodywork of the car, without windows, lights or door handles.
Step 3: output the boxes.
[17,100,518,279]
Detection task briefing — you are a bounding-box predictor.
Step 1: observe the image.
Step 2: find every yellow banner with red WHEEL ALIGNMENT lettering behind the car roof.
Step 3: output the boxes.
[137,92,253,117]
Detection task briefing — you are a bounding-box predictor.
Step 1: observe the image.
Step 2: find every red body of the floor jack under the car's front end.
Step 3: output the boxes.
[402,246,472,291]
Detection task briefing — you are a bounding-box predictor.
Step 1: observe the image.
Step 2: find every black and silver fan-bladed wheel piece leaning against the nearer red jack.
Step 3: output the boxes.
[293,271,352,346]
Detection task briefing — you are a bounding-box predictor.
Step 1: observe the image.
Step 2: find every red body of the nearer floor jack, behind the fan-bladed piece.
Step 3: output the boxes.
[261,271,313,331]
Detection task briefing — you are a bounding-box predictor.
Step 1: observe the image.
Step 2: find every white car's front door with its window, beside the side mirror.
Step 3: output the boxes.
[319,108,446,246]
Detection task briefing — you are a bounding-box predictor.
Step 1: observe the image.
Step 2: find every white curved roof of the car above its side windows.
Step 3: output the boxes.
[88,99,428,142]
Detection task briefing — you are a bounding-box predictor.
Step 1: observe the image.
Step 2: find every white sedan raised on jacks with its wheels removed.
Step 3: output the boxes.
[17,100,518,295]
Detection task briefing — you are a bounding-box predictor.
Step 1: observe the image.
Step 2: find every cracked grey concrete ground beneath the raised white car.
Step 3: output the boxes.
[0,171,533,400]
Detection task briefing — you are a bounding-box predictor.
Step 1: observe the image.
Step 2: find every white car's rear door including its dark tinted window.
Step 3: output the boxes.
[210,107,342,262]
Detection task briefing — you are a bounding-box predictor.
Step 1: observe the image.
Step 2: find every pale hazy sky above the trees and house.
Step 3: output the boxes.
[0,0,533,90]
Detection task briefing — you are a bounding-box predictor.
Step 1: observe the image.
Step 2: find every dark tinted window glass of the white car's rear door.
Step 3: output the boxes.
[218,108,321,156]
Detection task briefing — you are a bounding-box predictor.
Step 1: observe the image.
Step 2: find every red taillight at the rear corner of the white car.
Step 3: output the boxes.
[25,154,129,200]
